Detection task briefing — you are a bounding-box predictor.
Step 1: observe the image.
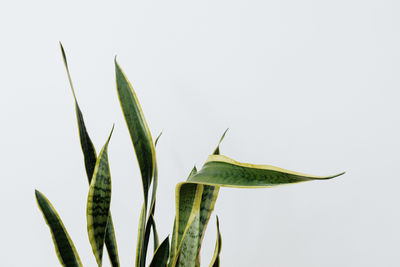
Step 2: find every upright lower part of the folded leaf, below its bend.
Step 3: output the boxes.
[169,183,203,266]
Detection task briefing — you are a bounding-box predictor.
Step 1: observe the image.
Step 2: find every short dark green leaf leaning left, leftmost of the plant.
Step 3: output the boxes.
[35,190,82,267]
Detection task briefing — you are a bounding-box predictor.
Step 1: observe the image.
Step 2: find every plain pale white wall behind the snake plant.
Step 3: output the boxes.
[0,0,400,267]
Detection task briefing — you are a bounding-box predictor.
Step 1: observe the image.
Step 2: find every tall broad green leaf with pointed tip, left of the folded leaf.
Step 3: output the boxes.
[115,60,156,208]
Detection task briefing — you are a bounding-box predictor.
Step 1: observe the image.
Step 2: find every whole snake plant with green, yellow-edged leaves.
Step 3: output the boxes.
[35,43,343,267]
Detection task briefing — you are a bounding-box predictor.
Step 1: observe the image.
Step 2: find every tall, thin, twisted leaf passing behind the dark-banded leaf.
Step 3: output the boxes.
[60,43,119,267]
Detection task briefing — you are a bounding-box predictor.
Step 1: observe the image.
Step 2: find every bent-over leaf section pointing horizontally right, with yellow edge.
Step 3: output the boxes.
[188,155,344,188]
